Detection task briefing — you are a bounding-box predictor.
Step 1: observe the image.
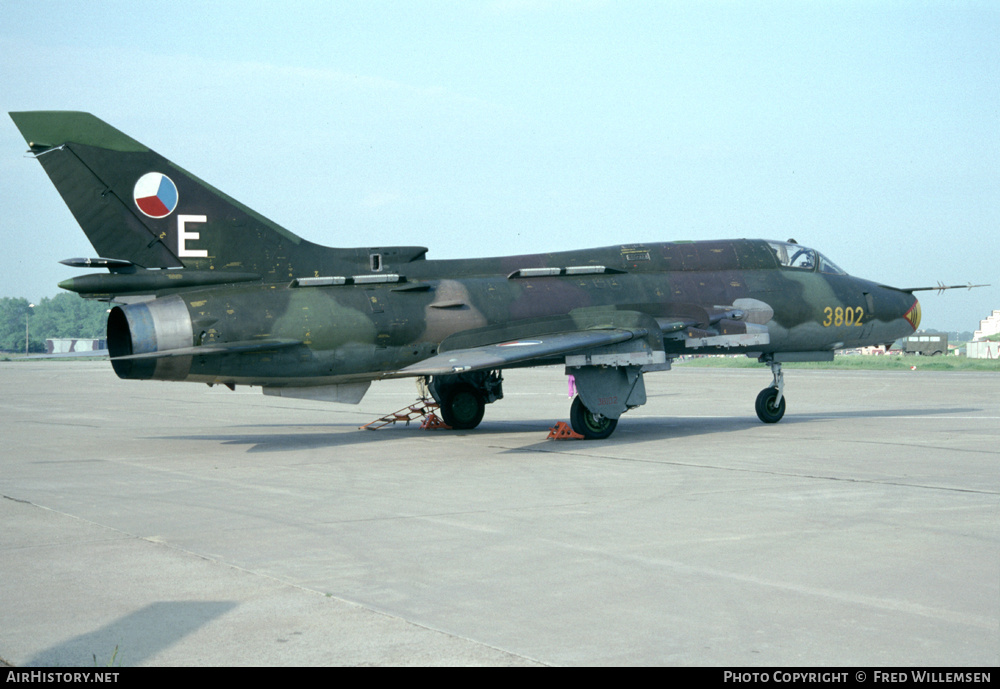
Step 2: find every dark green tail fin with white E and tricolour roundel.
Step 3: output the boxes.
[10,111,308,280]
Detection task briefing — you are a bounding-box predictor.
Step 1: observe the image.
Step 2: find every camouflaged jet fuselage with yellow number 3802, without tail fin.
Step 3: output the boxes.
[109,240,916,386]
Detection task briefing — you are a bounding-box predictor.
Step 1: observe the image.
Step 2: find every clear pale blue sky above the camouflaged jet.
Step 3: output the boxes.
[0,0,1000,330]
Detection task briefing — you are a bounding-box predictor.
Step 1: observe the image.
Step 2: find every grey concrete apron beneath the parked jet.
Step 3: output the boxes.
[0,361,1000,667]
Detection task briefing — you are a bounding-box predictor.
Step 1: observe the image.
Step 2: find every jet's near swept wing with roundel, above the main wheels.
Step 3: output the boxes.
[385,328,647,378]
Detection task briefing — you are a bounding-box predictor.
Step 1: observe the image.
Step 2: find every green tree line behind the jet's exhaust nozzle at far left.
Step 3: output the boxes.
[0,293,109,354]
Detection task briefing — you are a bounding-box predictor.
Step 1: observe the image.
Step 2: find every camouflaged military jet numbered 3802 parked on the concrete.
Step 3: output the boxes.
[11,112,937,439]
